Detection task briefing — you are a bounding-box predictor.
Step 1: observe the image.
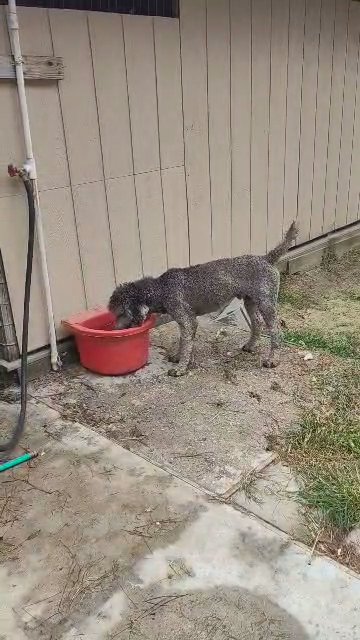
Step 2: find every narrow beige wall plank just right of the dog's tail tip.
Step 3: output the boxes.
[298,0,321,243]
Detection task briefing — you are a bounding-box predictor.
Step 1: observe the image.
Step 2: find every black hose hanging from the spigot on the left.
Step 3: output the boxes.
[0,167,35,452]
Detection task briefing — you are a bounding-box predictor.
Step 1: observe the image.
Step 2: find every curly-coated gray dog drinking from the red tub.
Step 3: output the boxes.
[109,222,297,376]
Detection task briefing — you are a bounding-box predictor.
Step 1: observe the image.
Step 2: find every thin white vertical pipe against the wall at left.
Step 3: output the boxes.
[7,0,61,371]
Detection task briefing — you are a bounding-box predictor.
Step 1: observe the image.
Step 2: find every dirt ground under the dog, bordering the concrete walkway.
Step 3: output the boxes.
[14,308,338,542]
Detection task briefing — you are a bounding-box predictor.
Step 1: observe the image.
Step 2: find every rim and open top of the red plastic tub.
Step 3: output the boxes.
[62,309,155,340]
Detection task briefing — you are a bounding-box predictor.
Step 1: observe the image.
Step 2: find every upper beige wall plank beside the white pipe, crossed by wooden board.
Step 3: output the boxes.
[18,7,70,189]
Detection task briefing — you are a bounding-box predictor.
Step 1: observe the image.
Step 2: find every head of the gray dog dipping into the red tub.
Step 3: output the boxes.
[108,282,149,329]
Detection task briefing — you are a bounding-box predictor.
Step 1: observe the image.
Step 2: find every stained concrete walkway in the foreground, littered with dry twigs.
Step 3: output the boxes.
[0,405,360,640]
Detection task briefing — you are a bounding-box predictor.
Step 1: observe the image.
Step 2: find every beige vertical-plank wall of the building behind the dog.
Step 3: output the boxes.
[0,0,360,348]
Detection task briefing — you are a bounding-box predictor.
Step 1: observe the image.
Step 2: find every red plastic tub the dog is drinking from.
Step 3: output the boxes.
[63,309,155,376]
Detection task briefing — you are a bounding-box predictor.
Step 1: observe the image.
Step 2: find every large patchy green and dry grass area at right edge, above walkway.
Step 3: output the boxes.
[272,361,360,532]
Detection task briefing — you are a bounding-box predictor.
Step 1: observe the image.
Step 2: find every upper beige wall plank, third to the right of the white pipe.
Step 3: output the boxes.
[88,12,133,178]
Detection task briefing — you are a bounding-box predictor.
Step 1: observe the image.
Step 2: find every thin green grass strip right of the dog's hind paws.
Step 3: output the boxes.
[284,329,360,358]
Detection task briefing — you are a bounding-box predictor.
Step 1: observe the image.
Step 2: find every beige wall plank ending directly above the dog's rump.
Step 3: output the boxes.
[250,0,271,253]
